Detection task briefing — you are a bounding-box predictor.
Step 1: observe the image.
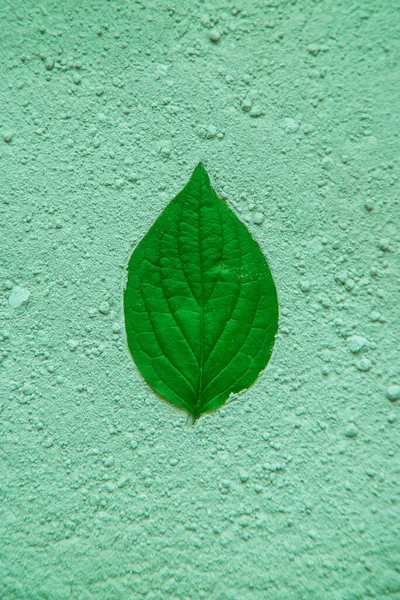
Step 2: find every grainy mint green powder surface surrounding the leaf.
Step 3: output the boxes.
[0,0,400,600]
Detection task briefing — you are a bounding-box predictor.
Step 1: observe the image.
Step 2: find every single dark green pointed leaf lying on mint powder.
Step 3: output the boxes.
[124,163,278,420]
